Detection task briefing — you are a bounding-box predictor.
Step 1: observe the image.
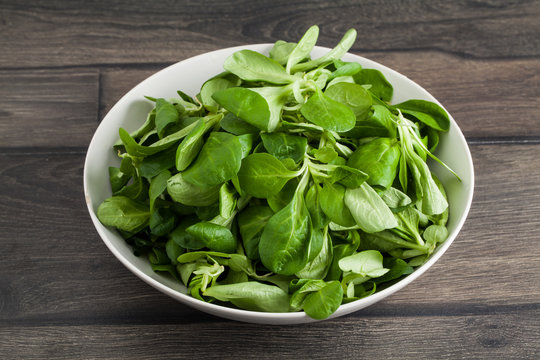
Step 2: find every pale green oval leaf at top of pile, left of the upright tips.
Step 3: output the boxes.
[226,50,296,84]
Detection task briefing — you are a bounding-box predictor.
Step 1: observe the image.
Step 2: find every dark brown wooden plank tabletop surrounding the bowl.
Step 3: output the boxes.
[0,0,540,359]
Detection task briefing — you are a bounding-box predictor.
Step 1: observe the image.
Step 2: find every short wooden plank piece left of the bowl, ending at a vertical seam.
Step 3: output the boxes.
[0,69,99,148]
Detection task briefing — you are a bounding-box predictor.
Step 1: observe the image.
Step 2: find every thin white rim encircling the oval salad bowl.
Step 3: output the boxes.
[83,43,474,324]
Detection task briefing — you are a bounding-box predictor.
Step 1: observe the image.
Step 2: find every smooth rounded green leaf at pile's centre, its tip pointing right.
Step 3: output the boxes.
[238,153,297,198]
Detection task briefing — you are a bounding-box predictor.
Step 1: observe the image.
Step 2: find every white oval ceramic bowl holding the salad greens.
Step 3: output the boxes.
[84,44,474,324]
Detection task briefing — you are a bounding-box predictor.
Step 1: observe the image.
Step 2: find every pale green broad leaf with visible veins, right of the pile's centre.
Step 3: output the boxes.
[344,183,398,233]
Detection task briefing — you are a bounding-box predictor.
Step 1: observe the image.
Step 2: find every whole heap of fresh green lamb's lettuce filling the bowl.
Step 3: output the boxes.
[97,26,457,319]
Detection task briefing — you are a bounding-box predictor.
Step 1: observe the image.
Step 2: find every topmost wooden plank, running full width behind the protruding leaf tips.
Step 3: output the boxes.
[0,0,540,68]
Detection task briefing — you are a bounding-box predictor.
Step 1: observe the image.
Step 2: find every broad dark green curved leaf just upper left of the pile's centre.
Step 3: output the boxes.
[183,132,242,188]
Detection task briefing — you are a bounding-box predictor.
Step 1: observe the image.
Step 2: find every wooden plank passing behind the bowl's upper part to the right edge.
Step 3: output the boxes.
[100,52,540,138]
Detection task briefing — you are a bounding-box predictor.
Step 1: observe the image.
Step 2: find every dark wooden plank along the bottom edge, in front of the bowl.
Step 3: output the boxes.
[0,309,540,360]
